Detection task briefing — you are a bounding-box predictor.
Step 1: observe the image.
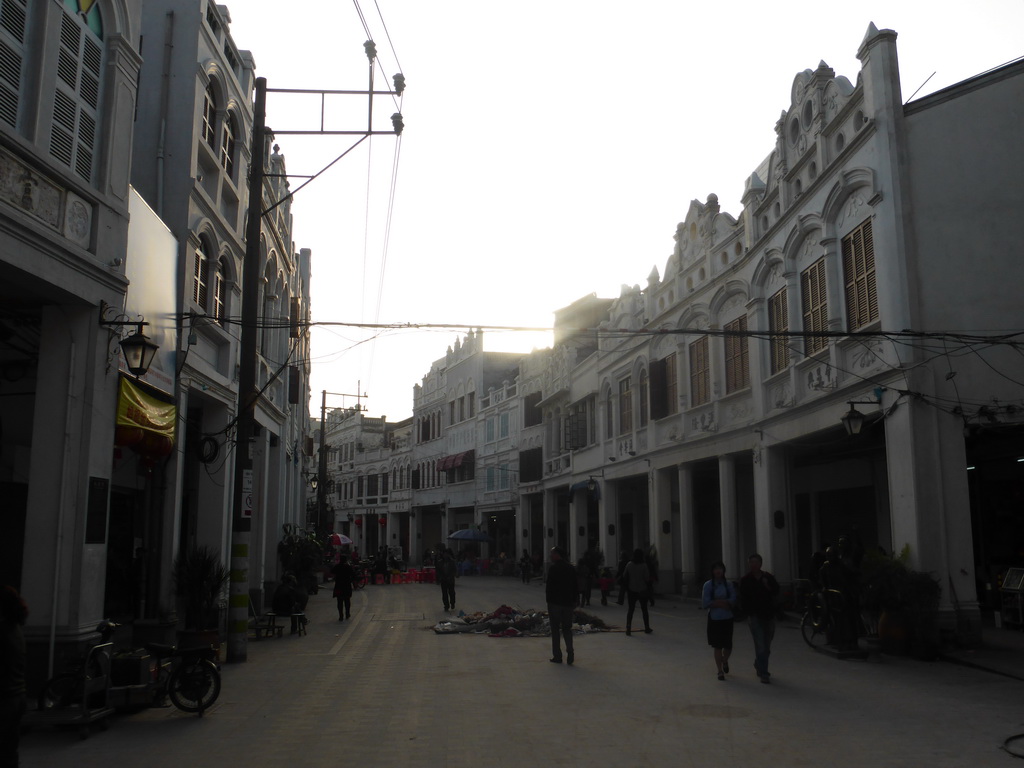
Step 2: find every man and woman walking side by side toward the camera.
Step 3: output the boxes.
[700,554,779,684]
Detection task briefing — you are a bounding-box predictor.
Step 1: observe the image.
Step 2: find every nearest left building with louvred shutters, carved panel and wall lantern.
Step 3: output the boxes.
[0,0,148,685]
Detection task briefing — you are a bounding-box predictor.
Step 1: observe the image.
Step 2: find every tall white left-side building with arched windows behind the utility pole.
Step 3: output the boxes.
[132,0,311,620]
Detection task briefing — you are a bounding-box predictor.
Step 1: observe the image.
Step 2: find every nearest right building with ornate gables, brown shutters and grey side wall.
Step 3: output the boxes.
[528,26,1024,628]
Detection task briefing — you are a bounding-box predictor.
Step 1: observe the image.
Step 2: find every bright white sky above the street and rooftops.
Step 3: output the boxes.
[228,0,1024,421]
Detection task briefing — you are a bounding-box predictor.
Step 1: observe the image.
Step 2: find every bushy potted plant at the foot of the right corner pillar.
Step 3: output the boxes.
[861,546,942,658]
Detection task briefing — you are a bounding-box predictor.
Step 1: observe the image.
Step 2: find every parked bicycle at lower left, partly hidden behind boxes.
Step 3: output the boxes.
[38,622,220,717]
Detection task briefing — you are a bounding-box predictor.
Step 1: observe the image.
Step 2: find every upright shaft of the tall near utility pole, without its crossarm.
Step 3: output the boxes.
[227,78,266,662]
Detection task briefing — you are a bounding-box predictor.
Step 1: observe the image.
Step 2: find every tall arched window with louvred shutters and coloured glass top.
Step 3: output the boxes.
[50,0,103,181]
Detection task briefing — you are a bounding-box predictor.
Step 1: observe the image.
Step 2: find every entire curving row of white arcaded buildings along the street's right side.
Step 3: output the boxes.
[327,25,1024,643]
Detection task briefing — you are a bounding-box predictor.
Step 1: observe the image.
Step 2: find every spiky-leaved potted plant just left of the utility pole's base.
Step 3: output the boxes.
[172,547,228,645]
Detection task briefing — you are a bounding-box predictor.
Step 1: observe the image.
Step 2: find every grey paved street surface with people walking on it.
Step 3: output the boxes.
[22,577,1024,768]
